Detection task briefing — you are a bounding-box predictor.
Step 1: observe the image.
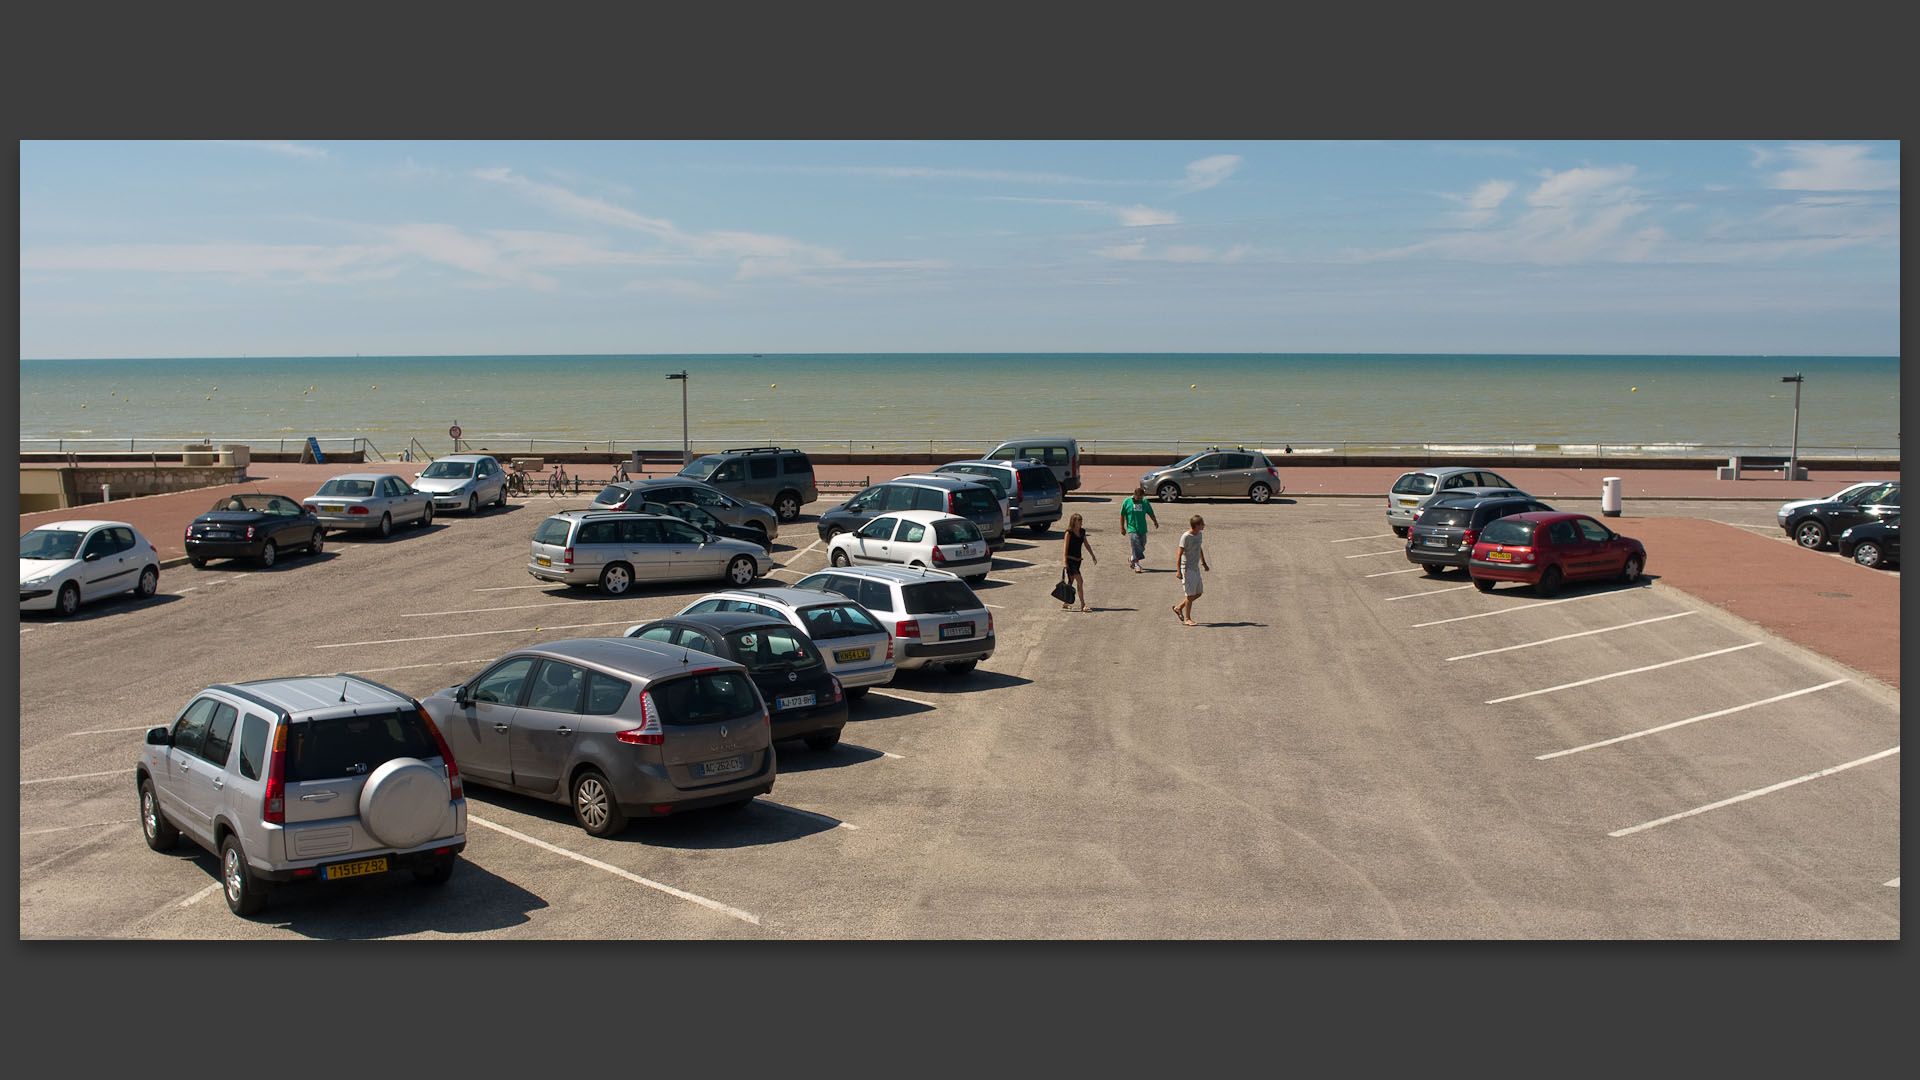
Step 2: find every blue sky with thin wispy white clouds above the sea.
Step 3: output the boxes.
[19,138,1901,359]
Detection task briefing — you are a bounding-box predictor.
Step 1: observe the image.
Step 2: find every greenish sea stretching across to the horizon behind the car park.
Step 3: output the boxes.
[19,354,1901,457]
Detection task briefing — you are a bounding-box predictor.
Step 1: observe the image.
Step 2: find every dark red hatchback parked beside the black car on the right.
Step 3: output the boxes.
[1467,511,1647,596]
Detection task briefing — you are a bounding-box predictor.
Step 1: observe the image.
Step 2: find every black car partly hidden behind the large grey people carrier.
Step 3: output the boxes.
[626,611,847,749]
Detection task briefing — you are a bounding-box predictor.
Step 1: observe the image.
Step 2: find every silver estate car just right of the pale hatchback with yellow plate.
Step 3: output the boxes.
[795,567,993,675]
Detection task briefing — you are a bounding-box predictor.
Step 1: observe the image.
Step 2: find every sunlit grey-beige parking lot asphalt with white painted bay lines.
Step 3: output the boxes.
[19,471,1899,940]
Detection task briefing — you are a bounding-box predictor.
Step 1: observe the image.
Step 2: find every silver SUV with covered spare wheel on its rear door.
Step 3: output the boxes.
[134,675,467,915]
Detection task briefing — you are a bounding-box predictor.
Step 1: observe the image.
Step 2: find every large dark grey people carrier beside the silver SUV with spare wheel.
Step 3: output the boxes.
[424,638,776,836]
